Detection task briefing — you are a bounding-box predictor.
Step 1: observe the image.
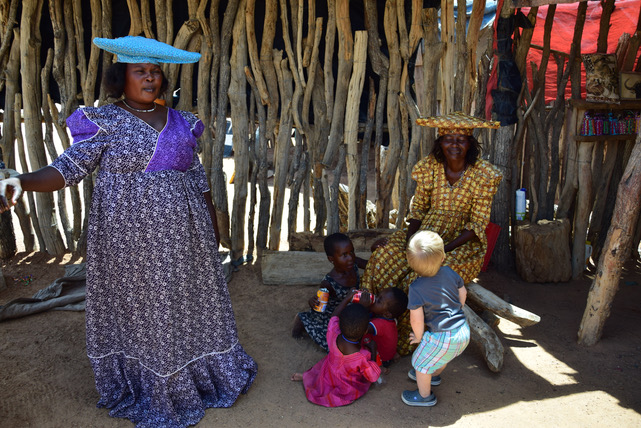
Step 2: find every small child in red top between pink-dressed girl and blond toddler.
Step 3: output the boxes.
[363,287,407,373]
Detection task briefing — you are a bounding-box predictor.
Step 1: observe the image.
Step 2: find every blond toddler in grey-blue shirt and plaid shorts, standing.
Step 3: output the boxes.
[401,231,470,406]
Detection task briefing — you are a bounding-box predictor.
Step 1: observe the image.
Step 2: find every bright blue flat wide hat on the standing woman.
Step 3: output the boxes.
[93,36,200,64]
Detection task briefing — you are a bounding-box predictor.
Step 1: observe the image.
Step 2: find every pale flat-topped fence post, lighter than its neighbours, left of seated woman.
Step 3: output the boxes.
[344,31,367,230]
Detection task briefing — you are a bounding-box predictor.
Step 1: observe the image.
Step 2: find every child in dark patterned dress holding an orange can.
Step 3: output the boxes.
[292,233,367,351]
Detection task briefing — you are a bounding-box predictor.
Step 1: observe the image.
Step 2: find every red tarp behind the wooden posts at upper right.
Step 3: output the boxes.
[521,0,641,102]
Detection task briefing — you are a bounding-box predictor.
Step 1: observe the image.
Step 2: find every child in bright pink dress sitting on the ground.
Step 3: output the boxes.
[291,293,381,407]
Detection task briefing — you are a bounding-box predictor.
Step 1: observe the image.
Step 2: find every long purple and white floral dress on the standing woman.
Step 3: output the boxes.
[52,104,257,427]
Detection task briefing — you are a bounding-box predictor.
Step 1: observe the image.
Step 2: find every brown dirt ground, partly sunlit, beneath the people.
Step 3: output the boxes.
[0,249,641,428]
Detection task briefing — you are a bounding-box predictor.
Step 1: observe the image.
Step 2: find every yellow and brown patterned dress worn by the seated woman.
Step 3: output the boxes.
[361,155,502,355]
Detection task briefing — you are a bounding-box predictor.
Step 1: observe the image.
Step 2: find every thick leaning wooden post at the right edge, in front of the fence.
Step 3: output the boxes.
[578,136,641,346]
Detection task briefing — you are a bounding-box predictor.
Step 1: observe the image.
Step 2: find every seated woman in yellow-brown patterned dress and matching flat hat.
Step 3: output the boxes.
[362,113,501,355]
